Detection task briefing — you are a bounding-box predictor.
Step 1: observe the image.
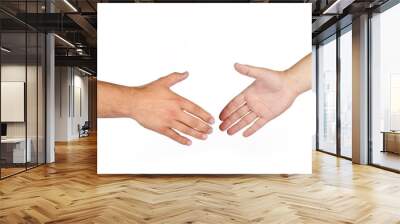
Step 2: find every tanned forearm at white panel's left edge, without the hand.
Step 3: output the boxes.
[97,81,135,118]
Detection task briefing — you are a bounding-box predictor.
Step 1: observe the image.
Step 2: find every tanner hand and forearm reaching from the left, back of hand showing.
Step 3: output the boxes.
[97,72,214,145]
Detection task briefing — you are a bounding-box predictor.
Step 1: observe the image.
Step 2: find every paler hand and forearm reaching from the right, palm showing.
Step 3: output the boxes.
[219,54,312,137]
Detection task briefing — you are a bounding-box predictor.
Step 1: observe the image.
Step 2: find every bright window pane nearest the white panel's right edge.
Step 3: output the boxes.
[318,39,336,153]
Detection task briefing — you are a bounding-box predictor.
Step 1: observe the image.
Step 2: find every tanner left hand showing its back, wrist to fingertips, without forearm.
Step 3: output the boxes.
[132,73,214,145]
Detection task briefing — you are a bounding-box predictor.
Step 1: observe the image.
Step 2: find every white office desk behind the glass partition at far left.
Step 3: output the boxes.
[1,138,32,163]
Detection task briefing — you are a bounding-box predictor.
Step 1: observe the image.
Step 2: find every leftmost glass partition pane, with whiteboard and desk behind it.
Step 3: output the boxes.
[1,32,30,178]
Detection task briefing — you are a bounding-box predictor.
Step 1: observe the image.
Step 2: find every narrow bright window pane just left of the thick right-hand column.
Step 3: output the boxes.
[340,30,353,158]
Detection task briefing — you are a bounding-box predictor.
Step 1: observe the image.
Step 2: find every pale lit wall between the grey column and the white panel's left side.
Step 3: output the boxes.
[55,67,89,141]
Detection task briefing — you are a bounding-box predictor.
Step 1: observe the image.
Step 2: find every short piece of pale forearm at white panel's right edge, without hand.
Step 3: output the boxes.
[285,53,312,95]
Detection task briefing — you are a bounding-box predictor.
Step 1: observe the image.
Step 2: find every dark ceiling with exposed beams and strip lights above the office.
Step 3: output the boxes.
[0,0,394,75]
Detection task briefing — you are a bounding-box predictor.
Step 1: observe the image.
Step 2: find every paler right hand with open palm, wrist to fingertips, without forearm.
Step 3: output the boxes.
[219,64,296,137]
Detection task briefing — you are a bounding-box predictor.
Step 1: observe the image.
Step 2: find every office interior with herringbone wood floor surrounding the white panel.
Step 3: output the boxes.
[0,0,400,223]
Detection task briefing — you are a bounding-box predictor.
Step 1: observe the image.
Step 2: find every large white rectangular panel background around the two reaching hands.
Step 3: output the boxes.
[97,3,315,174]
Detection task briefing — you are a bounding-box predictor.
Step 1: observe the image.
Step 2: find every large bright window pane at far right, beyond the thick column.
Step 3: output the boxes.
[371,4,400,170]
